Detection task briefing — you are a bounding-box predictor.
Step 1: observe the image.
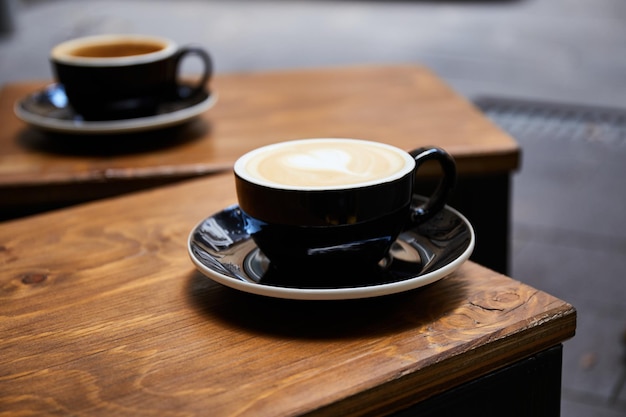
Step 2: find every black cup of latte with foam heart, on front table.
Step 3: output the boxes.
[234,138,456,271]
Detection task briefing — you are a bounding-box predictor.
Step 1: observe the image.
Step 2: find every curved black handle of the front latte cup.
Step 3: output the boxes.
[409,147,456,226]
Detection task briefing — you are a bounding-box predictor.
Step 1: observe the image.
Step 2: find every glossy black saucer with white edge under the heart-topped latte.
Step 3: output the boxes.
[187,196,475,300]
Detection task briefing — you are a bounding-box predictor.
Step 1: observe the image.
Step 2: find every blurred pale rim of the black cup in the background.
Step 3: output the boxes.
[50,34,178,67]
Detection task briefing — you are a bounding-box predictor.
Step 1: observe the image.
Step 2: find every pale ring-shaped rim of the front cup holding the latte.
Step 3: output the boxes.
[233,138,415,191]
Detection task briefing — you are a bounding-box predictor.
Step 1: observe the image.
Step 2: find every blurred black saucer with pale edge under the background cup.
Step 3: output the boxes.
[14,84,217,135]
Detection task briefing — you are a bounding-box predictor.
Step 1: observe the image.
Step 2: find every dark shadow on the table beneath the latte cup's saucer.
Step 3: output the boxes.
[187,272,467,339]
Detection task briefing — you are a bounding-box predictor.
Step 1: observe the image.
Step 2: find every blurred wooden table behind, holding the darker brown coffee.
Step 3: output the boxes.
[0,66,520,272]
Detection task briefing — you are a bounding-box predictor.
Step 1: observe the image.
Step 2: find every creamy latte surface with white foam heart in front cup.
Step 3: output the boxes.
[235,139,415,189]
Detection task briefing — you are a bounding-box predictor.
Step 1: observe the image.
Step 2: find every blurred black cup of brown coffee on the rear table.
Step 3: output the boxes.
[50,34,213,120]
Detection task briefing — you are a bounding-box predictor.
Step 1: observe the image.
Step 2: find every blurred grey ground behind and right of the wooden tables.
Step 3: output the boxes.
[0,0,626,417]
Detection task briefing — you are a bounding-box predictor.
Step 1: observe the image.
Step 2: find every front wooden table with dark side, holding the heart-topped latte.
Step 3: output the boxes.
[0,173,576,417]
